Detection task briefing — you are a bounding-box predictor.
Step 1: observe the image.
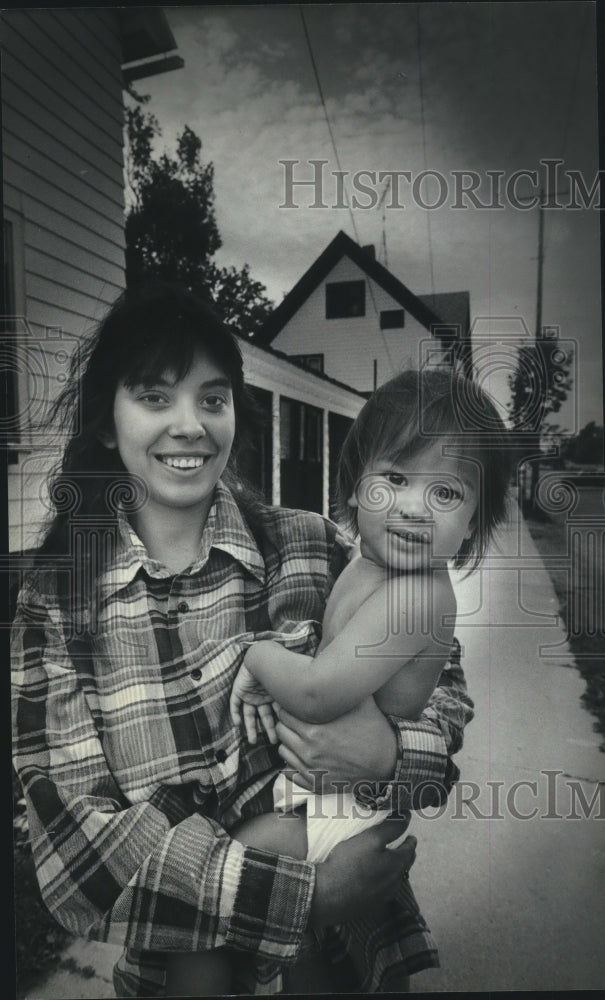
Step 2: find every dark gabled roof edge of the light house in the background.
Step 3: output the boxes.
[253,230,446,346]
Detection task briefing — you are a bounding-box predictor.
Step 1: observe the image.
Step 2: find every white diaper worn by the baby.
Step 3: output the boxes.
[273,772,397,862]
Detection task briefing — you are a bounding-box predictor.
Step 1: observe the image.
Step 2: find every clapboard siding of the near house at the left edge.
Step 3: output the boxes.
[2,8,125,549]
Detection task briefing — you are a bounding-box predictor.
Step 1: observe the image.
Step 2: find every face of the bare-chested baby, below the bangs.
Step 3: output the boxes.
[349,441,480,572]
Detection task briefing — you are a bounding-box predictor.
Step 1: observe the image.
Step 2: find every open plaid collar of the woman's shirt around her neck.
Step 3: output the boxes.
[99,481,265,596]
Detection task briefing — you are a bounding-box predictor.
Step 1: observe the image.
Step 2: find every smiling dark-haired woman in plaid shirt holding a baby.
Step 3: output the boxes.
[13,285,471,996]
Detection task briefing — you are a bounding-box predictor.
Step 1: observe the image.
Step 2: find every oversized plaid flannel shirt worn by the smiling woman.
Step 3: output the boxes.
[13,483,472,996]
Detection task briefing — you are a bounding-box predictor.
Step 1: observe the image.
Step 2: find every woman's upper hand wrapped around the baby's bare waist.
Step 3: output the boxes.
[276,698,397,793]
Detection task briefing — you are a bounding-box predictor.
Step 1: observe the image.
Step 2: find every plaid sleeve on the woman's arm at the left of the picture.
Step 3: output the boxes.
[12,594,315,963]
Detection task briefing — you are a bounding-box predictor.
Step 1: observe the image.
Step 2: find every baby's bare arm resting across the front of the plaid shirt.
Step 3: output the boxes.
[241,581,437,723]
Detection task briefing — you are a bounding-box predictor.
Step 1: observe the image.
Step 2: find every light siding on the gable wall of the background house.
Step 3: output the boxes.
[271,256,430,392]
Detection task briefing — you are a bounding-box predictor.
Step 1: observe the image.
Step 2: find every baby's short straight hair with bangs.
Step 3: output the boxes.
[336,368,512,572]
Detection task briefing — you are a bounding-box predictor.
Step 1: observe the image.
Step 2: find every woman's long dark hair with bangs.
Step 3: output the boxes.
[39,282,258,572]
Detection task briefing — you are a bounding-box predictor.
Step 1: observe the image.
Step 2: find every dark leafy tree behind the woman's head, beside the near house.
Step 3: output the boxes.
[126,99,273,337]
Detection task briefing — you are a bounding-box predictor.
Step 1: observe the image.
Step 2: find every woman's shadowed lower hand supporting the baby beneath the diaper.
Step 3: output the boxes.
[310,819,416,926]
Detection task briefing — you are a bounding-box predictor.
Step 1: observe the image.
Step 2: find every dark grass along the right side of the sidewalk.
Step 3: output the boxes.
[525,512,605,752]
